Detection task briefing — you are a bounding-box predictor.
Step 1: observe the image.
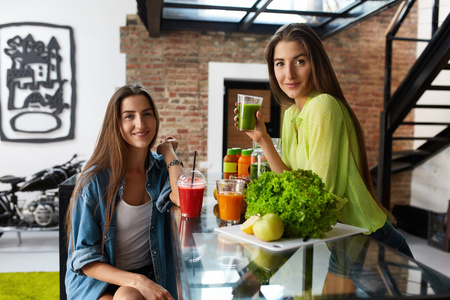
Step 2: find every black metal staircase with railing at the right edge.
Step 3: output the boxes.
[371,0,450,209]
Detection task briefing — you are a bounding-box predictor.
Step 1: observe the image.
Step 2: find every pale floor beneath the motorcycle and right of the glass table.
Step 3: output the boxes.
[0,231,450,277]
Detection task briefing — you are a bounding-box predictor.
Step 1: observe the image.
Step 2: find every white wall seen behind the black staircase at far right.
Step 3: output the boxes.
[411,0,450,213]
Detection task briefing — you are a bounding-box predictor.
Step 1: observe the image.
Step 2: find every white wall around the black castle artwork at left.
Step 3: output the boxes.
[0,0,137,189]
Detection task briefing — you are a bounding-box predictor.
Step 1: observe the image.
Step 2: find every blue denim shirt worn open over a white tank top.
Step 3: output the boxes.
[65,151,176,299]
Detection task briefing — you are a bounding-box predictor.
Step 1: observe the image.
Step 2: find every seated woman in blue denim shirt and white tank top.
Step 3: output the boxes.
[66,84,183,299]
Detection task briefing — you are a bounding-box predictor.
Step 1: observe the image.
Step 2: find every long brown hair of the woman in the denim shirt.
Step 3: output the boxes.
[65,83,160,251]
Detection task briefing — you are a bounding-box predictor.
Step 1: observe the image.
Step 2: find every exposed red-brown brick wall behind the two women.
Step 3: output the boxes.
[120,2,417,207]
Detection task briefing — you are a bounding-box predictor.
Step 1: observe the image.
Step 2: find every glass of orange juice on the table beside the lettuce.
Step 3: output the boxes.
[216,179,246,224]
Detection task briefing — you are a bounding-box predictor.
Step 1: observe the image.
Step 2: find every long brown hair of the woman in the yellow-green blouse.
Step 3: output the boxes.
[265,23,395,222]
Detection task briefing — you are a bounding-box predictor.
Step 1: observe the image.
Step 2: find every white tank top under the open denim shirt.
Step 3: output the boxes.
[116,199,152,271]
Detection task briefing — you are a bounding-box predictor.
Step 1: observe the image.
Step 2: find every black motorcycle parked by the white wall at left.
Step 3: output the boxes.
[0,154,84,236]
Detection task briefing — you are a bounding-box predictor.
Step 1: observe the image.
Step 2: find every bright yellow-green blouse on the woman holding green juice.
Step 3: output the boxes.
[282,91,387,233]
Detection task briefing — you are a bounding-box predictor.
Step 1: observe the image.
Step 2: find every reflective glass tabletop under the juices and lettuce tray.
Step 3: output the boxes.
[171,193,450,300]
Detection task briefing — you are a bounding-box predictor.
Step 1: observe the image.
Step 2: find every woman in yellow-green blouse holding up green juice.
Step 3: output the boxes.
[237,23,412,256]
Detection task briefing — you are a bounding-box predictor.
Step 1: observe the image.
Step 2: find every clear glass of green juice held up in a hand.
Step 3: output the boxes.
[237,94,263,132]
